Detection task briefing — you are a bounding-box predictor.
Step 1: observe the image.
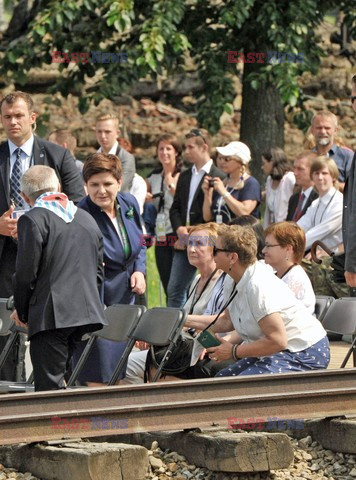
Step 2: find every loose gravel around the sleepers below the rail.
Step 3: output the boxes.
[0,437,356,480]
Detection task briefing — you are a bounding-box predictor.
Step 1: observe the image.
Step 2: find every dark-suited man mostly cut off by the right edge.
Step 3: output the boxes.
[342,75,356,288]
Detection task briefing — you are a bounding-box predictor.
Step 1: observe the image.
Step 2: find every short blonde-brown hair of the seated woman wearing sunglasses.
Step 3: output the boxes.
[218,224,257,267]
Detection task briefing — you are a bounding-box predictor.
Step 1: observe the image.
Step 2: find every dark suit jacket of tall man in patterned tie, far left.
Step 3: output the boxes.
[0,136,85,282]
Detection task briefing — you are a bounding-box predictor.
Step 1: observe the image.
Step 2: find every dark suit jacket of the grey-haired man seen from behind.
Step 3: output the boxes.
[14,208,107,337]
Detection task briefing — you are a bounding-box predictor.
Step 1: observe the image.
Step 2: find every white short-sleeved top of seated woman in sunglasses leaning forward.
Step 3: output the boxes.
[224,262,326,352]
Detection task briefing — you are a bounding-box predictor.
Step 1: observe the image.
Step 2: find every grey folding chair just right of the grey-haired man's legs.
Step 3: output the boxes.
[67,305,146,387]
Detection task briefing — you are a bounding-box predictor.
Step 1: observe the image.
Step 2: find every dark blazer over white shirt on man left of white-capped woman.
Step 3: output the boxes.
[169,164,226,232]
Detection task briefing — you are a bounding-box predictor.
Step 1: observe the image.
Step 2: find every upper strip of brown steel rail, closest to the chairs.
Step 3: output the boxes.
[0,368,356,415]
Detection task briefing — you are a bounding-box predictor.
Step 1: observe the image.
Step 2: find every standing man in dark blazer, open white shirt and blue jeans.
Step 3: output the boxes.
[167,129,225,307]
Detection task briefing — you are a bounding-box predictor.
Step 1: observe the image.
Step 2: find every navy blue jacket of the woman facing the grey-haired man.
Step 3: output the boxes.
[78,193,146,306]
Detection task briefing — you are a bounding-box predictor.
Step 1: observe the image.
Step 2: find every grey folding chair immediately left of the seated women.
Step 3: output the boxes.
[108,307,186,385]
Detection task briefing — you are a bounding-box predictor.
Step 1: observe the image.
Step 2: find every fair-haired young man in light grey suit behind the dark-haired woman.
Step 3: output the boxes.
[95,113,136,192]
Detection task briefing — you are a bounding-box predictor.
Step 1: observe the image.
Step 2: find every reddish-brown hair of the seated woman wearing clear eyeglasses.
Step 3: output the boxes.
[265,222,306,264]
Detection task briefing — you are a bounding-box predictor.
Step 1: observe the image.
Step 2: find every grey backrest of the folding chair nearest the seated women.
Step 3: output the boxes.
[132,307,186,345]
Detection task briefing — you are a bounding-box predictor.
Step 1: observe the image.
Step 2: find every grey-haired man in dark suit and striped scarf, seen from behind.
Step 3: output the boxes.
[12,165,107,391]
